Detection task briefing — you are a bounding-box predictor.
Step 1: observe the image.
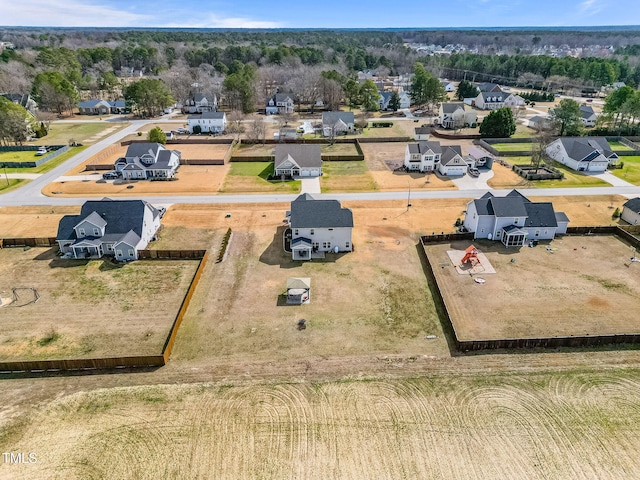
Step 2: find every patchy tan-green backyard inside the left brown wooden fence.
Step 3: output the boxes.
[0,248,197,360]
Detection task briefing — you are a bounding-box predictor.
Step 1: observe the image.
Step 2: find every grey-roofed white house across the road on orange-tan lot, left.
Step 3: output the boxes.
[115,142,180,180]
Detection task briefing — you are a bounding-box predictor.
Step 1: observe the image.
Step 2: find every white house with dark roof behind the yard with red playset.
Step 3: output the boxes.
[463,190,569,247]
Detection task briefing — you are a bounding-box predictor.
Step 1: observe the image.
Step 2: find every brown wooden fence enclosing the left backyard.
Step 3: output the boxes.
[0,250,209,374]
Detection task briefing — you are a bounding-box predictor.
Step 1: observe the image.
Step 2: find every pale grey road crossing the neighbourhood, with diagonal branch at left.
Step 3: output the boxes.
[0,119,640,206]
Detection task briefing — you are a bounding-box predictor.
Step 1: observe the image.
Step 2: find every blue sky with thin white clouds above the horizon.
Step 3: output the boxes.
[0,0,640,28]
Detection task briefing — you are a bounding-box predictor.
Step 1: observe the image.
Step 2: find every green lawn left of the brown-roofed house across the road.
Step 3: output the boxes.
[220,162,300,193]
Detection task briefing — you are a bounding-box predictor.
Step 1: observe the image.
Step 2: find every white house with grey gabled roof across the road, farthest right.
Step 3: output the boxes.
[545,137,618,172]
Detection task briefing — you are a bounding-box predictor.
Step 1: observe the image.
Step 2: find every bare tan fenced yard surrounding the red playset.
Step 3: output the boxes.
[427,236,640,340]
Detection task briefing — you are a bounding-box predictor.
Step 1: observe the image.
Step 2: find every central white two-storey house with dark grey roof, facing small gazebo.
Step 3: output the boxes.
[288,193,353,260]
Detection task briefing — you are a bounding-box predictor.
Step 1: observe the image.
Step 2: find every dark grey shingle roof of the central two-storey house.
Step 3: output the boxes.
[291,194,353,228]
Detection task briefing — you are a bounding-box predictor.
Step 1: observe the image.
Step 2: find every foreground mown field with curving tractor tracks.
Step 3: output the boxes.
[0,369,640,480]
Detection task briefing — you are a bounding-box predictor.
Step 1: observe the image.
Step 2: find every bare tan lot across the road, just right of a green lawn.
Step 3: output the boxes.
[360,142,456,191]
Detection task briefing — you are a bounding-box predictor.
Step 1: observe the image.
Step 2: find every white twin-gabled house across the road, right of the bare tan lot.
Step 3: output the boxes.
[404,141,468,175]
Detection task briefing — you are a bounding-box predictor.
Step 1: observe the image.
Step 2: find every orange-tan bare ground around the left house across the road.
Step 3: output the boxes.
[42,164,229,197]
